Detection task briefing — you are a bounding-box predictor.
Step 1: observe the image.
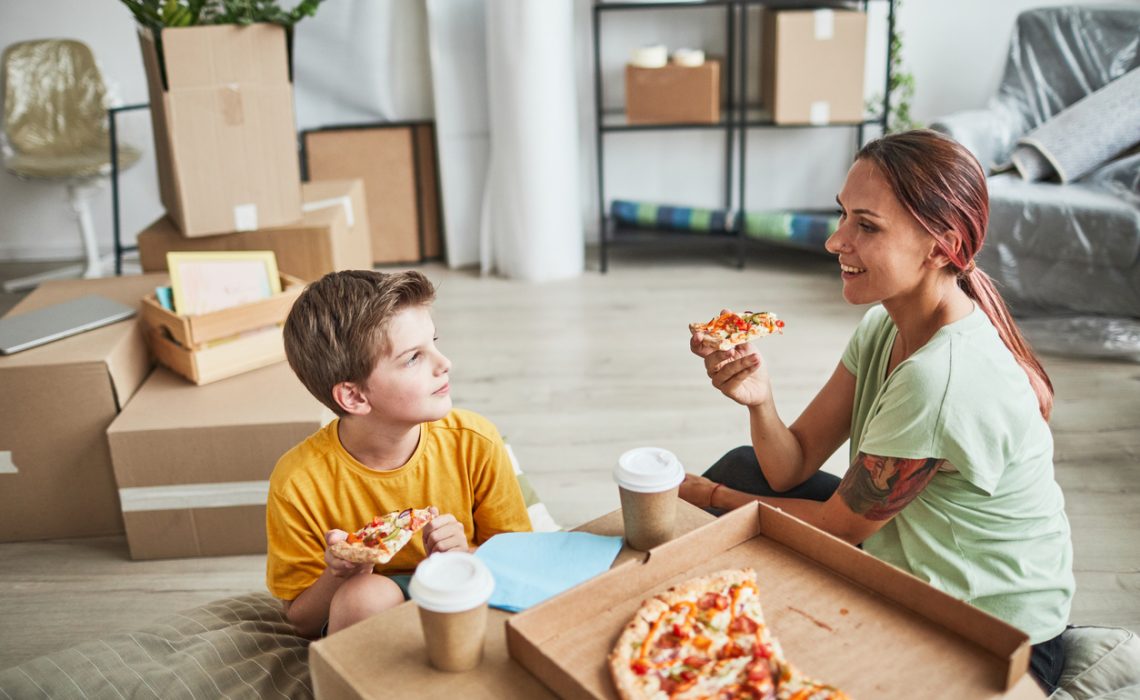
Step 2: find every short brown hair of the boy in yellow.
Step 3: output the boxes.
[285,270,435,416]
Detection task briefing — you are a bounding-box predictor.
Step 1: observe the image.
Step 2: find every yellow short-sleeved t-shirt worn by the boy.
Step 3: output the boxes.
[266,409,530,601]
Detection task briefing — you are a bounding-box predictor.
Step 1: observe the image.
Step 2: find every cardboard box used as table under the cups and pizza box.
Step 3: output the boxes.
[309,503,713,700]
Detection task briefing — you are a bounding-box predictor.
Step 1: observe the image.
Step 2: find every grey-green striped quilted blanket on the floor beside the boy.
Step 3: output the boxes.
[0,594,312,700]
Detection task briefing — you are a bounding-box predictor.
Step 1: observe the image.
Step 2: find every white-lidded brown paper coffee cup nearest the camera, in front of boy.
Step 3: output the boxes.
[408,552,495,671]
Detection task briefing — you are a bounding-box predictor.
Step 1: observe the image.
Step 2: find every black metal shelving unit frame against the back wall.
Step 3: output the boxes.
[593,0,895,272]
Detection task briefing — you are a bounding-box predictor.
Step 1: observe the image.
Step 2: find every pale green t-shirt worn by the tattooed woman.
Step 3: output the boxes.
[842,306,1075,644]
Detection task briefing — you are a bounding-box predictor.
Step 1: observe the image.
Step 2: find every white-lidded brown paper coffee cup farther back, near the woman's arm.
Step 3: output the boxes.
[613,447,685,551]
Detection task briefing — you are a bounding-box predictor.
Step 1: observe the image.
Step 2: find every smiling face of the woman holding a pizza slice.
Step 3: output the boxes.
[827,160,938,304]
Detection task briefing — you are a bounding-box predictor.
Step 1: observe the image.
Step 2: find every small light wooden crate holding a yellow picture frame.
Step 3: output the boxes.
[143,275,304,384]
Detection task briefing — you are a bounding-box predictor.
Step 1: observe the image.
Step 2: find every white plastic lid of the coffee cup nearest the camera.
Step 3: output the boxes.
[408,552,495,612]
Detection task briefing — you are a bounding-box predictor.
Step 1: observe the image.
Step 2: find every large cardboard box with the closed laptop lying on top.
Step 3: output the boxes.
[0,275,169,542]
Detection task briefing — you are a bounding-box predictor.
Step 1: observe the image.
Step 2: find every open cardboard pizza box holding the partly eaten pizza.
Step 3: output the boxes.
[506,503,1044,699]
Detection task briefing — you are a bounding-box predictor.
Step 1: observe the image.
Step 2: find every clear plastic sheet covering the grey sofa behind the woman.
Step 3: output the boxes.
[931,3,1140,359]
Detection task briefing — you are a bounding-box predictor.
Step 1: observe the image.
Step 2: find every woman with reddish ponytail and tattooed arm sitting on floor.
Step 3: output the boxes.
[681,130,1074,692]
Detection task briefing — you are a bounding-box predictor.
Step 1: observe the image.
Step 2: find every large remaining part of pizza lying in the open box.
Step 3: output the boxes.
[610,569,847,700]
